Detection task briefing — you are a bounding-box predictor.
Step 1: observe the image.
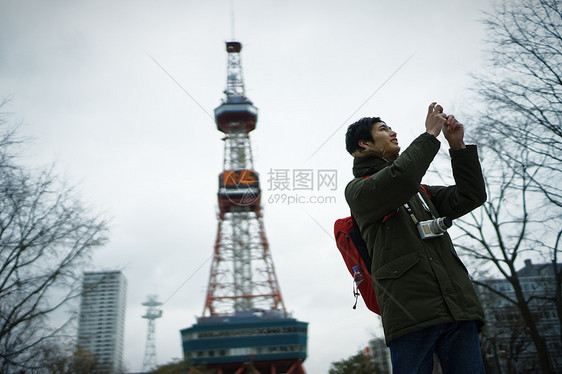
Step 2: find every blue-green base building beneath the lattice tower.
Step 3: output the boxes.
[181,310,308,374]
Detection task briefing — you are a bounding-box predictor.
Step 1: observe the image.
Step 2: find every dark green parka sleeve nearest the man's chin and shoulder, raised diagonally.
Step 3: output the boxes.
[345,133,440,222]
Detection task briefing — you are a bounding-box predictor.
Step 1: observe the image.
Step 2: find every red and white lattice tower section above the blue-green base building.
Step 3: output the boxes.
[203,42,286,316]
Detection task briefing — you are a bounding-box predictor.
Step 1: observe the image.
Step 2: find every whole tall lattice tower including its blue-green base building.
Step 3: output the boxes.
[181,41,308,374]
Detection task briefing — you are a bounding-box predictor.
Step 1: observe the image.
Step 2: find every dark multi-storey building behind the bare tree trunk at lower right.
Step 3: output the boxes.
[476,260,562,374]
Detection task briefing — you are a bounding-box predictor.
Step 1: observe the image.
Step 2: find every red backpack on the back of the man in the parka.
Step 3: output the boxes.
[334,216,381,315]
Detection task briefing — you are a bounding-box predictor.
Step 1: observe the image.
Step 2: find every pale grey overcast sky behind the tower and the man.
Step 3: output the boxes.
[0,0,492,374]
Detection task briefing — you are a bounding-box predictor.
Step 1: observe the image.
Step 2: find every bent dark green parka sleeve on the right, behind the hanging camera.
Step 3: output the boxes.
[425,145,487,219]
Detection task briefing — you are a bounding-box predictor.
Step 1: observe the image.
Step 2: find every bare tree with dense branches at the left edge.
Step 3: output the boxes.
[0,102,107,373]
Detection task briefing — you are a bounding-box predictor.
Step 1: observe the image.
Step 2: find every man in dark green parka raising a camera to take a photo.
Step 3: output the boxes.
[345,103,486,374]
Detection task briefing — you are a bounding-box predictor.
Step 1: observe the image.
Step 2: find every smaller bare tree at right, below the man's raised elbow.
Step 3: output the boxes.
[455,139,554,373]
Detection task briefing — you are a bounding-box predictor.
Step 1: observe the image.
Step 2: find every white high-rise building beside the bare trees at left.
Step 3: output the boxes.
[78,271,127,374]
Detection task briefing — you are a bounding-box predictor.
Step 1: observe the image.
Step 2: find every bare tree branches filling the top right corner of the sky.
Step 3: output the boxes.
[470,0,562,208]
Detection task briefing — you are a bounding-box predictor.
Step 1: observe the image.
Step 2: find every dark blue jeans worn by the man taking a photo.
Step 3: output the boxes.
[388,321,484,374]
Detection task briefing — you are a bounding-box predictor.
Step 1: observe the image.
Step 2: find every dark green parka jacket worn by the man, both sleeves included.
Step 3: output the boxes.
[345,133,486,343]
